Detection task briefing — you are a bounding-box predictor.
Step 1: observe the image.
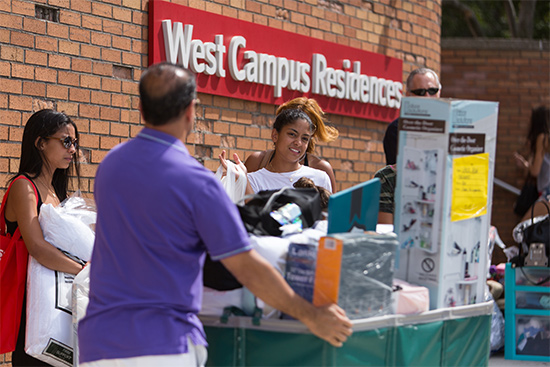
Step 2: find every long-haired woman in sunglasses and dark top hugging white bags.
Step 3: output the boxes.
[4,109,82,366]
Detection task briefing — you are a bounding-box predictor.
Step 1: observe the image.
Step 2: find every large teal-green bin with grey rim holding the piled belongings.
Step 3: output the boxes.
[201,302,493,367]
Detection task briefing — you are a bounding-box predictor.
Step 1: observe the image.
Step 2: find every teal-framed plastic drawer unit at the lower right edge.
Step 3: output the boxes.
[504,263,550,362]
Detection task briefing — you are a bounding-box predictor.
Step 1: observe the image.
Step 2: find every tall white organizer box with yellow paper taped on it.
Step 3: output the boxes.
[394,97,498,309]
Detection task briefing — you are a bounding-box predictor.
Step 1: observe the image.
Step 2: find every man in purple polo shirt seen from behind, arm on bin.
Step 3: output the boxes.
[79,63,351,366]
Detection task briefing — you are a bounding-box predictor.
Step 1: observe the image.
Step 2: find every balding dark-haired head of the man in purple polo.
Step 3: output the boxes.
[139,63,197,126]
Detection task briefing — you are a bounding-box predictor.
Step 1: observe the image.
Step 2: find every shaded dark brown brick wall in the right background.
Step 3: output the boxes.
[441,39,550,261]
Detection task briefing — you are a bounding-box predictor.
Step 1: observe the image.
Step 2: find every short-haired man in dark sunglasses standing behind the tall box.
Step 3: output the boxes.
[384,68,441,165]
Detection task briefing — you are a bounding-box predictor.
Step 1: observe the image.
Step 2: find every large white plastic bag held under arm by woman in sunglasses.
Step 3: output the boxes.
[25,196,95,366]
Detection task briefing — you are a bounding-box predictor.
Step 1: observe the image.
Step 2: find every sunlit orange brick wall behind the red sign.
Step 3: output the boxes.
[0,0,441,197]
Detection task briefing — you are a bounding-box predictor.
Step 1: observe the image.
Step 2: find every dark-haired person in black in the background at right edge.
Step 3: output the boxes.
[514,106,550,204]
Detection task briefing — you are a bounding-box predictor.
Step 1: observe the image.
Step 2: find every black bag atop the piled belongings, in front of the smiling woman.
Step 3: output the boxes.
[239,187,322,236]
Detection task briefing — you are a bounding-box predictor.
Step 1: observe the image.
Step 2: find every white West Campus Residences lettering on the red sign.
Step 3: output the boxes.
[162,19,403,109]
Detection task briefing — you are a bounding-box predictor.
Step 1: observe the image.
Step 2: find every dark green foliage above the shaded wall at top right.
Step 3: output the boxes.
[441,0,550,40]
